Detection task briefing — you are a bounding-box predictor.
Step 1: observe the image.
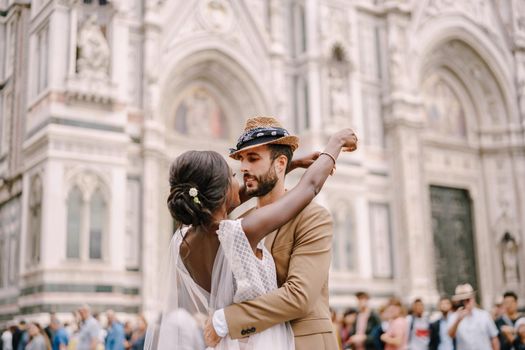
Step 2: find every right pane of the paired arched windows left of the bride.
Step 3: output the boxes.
[89,190,107,259]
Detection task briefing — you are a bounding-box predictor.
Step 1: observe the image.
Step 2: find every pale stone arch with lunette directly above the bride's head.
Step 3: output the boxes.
[159,47,268,147]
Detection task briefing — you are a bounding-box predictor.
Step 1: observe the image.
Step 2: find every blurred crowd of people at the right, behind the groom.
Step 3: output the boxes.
[332,284,525,350]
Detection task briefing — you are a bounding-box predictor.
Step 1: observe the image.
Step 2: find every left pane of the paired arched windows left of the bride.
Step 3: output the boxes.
[66,186,83,259]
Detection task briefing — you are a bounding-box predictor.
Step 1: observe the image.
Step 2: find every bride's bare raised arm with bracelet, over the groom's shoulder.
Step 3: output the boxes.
[242,129,357,247]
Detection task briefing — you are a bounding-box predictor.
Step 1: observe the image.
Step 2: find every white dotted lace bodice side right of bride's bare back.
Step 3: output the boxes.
[217,220,277,303]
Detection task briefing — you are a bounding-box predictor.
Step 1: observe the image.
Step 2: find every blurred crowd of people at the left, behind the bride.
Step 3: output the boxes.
[0,305,147,350]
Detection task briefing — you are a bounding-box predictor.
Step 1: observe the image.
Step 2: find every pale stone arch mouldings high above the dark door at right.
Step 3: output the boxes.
[408,16,519,127]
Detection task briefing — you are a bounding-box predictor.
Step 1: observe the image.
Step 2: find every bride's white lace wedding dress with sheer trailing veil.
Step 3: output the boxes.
[144,220,295,350]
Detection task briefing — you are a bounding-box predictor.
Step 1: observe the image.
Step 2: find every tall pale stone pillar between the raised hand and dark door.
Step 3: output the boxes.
[385,3,437,301]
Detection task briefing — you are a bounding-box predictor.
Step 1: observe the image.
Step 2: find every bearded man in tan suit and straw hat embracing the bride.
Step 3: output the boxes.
[204,117,342,350]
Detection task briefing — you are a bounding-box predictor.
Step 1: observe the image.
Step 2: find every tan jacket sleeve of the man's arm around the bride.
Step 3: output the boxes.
[224,205,332,339]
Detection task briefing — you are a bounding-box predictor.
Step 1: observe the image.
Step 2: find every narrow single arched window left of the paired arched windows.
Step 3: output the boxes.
[27,176,42,265]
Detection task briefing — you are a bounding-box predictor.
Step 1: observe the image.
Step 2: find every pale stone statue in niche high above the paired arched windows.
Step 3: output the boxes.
[77,14,110,79]
